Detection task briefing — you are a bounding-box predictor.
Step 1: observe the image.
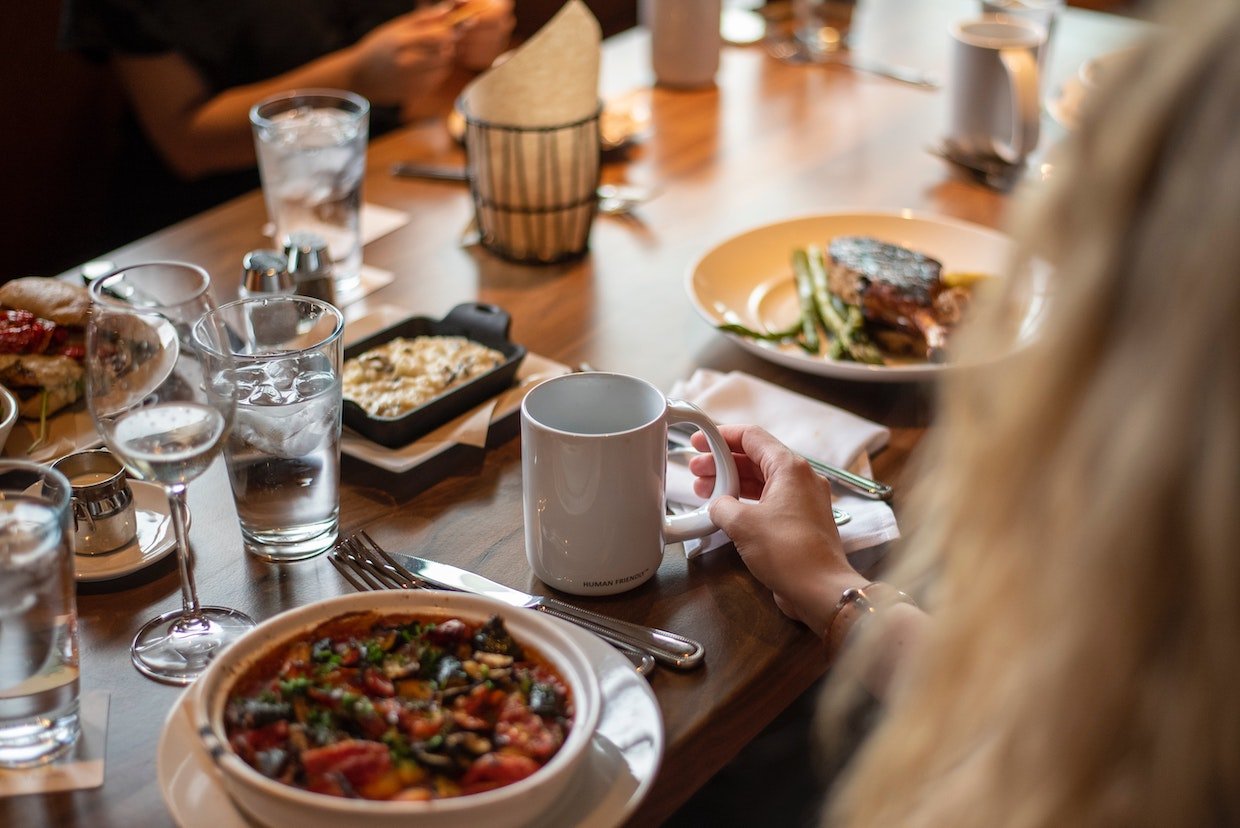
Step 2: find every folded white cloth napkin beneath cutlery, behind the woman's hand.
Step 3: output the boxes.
[667,369,900,558]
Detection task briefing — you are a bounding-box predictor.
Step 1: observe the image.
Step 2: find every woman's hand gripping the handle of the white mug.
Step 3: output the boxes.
[689,425,867,636]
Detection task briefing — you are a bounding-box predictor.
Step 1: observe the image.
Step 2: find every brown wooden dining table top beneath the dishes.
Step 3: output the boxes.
[0,0,1146,828]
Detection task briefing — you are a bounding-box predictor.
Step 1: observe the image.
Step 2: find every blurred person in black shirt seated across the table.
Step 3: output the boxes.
[61,0,515,249]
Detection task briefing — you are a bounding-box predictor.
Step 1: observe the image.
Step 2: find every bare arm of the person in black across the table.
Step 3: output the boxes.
[113,7,454,180]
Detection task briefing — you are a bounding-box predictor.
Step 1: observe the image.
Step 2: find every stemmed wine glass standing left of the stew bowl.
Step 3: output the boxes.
[86,262,254,684]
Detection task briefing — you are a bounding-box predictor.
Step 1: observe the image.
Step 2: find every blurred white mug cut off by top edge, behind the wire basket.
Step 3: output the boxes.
[641,0,723,89]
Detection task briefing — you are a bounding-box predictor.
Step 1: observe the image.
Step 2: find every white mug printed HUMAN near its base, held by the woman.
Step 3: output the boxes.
[521,373,739,595]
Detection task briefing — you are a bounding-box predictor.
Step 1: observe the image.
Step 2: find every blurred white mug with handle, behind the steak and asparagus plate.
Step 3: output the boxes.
[947,16,1047,164]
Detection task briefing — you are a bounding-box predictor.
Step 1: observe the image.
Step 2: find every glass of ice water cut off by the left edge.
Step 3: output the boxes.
[0,460,79,767]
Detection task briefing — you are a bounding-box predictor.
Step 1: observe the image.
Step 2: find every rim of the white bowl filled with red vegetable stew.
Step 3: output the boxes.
[191,590,601,818]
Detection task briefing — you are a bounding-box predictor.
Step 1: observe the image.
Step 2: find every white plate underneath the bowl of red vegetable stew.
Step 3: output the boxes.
[155,619,663,828]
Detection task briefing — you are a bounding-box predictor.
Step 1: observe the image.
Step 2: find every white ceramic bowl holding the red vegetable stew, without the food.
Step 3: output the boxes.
[191,590,601,828]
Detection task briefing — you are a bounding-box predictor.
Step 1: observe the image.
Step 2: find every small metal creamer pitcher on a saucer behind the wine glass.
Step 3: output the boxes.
[52,449,138,555]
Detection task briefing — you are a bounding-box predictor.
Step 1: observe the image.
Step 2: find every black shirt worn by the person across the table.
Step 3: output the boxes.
[61,0,414,245]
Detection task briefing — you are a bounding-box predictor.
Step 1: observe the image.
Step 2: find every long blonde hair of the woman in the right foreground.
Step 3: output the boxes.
[827,0,1240,828]
